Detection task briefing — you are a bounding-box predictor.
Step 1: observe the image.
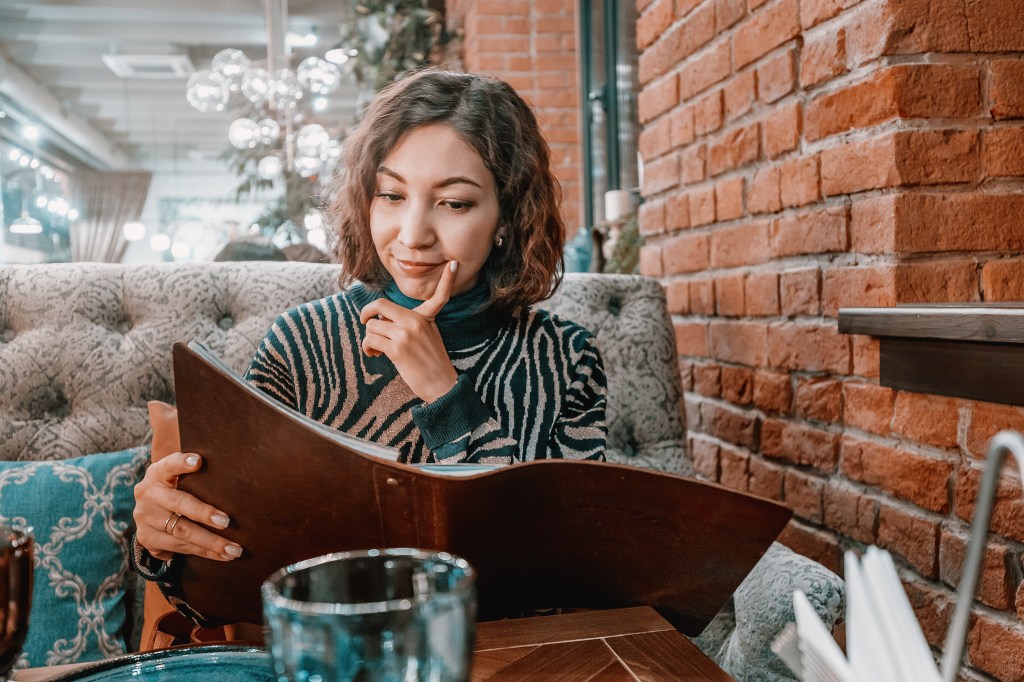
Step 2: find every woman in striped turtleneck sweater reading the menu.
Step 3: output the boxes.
[134,71,606,622]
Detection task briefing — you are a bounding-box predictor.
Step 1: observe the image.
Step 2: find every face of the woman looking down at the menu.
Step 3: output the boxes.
[370,124,499,300]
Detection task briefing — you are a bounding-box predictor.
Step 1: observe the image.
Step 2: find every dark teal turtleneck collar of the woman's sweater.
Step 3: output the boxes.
[349,276,508,350]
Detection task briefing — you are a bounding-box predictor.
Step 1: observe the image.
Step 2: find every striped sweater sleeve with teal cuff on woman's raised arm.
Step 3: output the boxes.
[413,335,607,464]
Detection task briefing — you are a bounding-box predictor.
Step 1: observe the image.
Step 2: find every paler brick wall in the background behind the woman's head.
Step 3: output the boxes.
[446,0,583,231]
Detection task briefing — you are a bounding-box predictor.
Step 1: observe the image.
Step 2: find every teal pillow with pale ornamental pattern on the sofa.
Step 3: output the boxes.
[0,446,150,668]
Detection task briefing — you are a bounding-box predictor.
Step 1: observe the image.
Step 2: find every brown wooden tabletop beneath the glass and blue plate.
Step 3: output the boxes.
[13,606,732,682]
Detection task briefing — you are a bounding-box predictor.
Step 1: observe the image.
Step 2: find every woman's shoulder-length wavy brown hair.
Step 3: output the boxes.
[328,69,565,310]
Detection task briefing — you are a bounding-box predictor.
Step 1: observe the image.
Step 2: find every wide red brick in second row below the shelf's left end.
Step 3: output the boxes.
[842,434,953,513]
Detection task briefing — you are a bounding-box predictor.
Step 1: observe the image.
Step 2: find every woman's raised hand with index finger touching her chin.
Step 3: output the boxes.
[359,260,459,402]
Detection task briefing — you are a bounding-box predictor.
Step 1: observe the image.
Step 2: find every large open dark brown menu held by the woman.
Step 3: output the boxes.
[174,341,792,635]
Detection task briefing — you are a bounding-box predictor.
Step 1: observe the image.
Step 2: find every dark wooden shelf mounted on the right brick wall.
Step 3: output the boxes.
[839,303,1024,406]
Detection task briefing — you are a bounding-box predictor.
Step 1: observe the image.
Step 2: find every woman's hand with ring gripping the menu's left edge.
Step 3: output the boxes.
[134,453,242,561]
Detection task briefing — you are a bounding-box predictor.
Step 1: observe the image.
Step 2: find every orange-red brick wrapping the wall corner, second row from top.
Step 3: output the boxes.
[804,65,981,140]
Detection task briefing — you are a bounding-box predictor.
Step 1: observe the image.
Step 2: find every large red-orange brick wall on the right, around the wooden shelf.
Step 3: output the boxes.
[637,0,1024,680]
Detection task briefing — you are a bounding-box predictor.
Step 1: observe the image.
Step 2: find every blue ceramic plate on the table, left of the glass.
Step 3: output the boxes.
[53,644,275,682]
